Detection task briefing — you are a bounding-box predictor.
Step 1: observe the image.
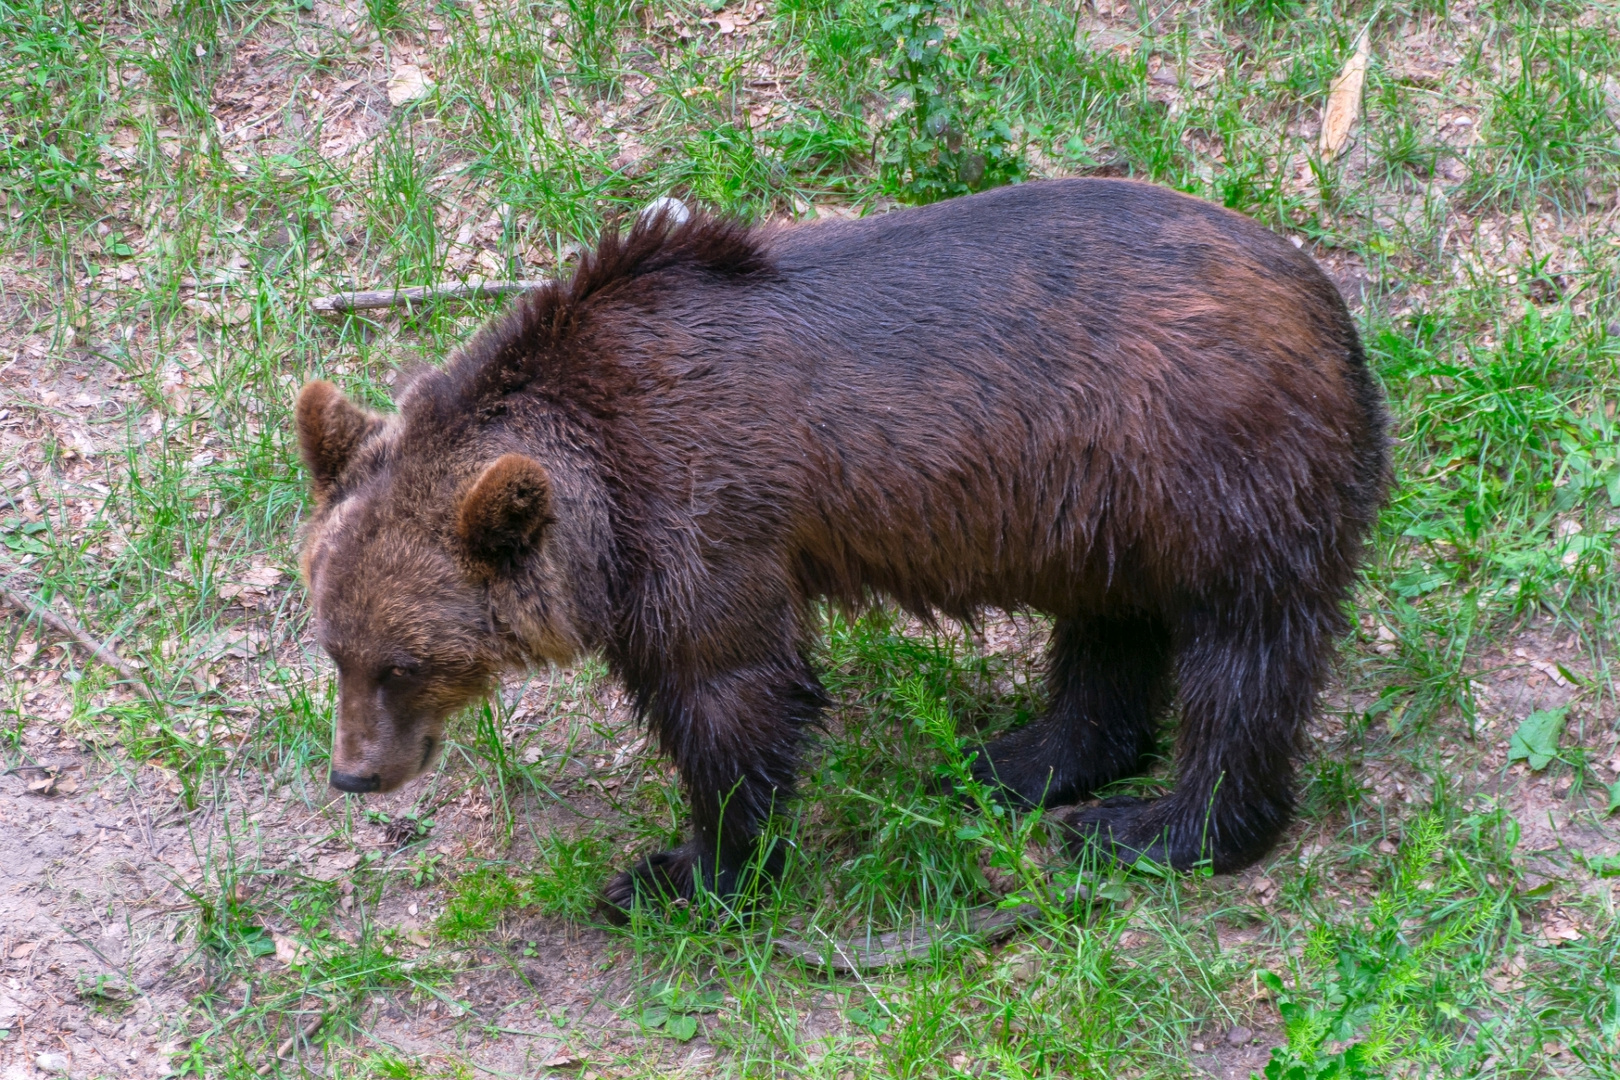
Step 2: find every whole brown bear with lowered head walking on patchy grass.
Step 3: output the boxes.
[296,180,1390,912]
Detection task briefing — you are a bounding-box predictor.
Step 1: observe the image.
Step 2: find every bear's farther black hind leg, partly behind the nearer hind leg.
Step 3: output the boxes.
[974,619,1171,806]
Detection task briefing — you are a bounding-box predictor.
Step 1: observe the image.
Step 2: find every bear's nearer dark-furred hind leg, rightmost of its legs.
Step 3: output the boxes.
[1064,601,1335,873]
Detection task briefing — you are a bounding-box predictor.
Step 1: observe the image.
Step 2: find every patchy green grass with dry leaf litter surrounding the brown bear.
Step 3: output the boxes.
[0,0,1620,1080]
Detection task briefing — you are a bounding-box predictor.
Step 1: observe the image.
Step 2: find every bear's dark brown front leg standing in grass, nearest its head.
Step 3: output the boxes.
[604,657,826,920]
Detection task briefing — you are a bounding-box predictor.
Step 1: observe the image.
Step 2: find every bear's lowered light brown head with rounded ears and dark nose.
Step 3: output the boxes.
[298,382,573,792]
